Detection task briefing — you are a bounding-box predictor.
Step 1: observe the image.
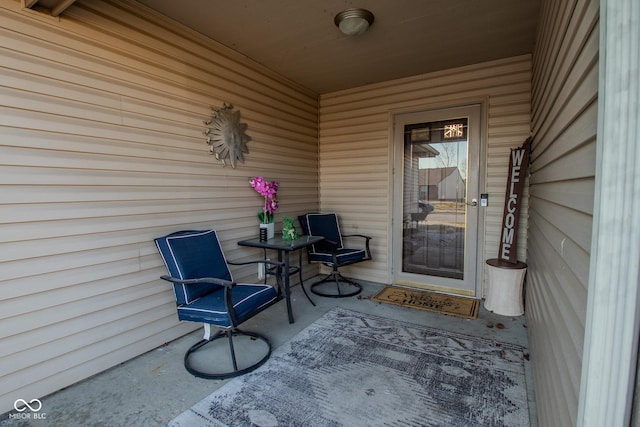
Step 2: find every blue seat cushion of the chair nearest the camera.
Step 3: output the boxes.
[178,283,278,328]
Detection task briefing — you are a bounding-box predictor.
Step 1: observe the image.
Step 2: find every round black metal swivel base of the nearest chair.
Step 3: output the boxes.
[184,329,271,380]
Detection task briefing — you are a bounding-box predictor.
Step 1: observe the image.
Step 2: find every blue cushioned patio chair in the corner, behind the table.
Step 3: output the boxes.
[298,213,371,298]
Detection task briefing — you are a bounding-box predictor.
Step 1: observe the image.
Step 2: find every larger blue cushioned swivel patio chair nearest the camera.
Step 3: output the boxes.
[155,230,280,379]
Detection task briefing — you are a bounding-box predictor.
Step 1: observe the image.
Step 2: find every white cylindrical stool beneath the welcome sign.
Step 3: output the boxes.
[484,258,527,316]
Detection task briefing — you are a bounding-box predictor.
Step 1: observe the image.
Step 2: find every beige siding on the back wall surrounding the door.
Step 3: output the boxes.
[320,55,531,288]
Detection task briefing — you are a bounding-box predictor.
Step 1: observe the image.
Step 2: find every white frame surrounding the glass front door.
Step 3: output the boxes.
[387,96,489,298]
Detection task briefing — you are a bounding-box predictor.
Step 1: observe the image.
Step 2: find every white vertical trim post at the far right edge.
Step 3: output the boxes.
[577,0,640,427]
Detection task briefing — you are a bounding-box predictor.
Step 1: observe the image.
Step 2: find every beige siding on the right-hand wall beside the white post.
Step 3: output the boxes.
[526,0,598,426]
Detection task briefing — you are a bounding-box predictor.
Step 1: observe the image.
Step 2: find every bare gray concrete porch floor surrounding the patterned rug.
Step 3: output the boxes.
[0,279,537,427]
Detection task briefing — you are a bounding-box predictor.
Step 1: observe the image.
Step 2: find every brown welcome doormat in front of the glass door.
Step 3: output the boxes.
[371,286,480,319]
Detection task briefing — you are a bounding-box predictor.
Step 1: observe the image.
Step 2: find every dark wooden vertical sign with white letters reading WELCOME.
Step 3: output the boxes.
[498,138,531,264]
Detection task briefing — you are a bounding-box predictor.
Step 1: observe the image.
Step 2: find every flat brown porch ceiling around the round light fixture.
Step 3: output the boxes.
[138,0,540,94]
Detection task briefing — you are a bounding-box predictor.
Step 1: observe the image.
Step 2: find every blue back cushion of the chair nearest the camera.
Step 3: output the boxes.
[155,230,233,305]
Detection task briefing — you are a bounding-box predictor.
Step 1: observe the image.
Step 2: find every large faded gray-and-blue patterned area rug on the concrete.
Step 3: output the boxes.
[167,308,529,427]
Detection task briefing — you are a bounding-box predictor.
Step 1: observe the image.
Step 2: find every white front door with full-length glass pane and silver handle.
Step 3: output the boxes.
[392,104,481,296]
